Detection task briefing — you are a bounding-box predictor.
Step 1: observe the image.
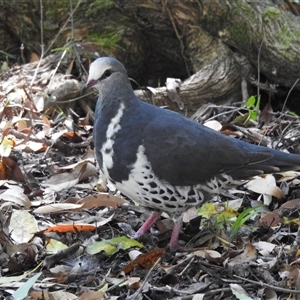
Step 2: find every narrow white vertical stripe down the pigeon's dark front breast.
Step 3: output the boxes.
[101,103,125,179]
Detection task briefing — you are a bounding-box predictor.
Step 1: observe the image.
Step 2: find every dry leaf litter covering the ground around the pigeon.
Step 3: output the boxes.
[0,51,300,299]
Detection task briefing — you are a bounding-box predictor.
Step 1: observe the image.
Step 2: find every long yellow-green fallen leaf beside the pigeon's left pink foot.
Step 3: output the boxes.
[86,236,143,255]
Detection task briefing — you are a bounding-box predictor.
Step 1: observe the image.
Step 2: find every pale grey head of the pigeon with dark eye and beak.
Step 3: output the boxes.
[82,57,129,93]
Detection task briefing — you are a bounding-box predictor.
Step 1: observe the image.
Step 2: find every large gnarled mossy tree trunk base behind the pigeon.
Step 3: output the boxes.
[0,0,300,115]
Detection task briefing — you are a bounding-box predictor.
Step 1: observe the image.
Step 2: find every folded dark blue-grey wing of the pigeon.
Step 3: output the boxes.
[143,115,272,185]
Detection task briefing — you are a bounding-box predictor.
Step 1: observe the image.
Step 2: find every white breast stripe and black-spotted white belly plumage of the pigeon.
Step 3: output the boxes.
[100,104,239,213]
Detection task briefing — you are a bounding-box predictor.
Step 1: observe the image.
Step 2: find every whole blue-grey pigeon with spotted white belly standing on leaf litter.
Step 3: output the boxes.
[84,57,300,248]
